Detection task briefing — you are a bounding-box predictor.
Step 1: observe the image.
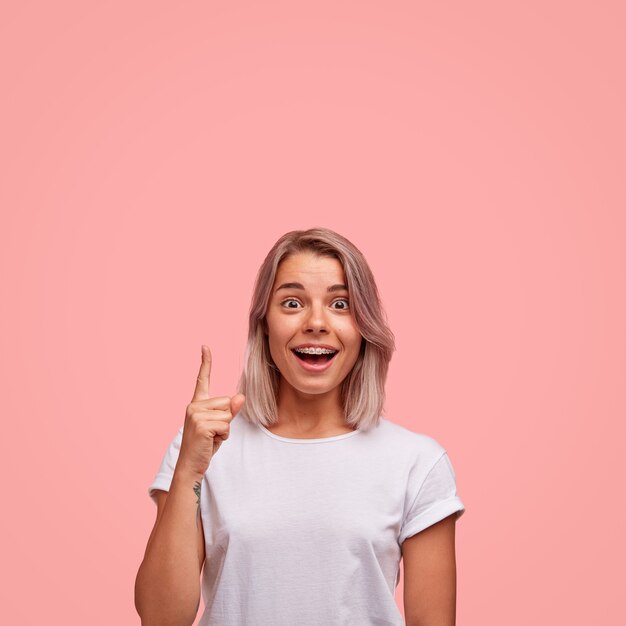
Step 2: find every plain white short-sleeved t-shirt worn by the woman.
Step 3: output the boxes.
[148,411,465,626]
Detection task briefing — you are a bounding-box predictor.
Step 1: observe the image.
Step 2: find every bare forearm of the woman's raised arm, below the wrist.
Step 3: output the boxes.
[135,468,202,626]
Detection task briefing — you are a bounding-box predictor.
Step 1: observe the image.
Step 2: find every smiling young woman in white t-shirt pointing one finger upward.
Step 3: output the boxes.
[135,228,465,626]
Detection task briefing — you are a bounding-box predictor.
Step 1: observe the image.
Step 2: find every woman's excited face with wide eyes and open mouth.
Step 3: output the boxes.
[266,252,362,396]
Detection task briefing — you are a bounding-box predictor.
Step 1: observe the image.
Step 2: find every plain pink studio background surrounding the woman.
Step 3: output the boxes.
[0,0,626,626]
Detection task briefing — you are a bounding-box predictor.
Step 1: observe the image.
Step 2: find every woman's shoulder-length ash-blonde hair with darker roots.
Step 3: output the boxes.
[237,228,395,430]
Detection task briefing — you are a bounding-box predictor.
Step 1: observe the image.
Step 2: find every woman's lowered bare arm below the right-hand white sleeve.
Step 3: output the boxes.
[402,513,457,626]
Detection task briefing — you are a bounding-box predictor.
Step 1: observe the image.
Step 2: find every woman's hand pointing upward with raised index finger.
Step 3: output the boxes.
[177,346,245,476]
